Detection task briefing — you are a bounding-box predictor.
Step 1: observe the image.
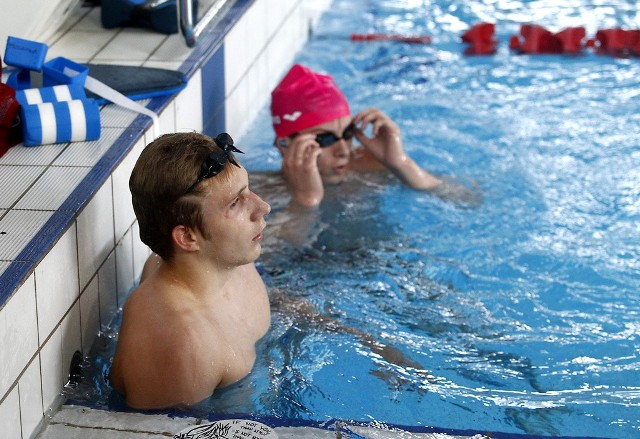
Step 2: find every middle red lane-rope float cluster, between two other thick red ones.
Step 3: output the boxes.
[509,24,586,54]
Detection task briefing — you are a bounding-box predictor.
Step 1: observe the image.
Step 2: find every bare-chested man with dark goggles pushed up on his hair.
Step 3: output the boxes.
[110,133,270,409]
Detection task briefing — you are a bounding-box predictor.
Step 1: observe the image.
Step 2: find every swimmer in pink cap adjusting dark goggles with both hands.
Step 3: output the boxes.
[271,64,443,207]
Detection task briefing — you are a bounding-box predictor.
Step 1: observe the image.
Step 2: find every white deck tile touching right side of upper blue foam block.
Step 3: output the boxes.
[47,29,115,64]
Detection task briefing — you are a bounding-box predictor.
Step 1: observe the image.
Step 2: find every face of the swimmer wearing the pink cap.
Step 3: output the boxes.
[301,116,352,184]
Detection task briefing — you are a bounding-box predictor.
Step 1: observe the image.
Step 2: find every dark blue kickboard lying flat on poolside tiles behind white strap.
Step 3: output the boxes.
[87,64,187,104]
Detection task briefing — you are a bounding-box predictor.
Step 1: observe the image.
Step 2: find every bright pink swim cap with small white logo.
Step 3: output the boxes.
[271,64,351,137]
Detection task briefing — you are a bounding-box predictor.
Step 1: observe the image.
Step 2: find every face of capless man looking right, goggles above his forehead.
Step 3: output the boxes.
[201,168,271,268]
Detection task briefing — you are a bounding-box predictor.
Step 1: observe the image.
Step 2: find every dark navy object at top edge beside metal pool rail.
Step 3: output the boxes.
[100,0,198,34]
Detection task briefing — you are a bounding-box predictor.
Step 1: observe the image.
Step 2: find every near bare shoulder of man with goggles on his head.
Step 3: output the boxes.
[111,282,224,408]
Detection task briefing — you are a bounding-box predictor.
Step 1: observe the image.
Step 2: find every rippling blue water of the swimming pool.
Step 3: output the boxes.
[66,0,640,438]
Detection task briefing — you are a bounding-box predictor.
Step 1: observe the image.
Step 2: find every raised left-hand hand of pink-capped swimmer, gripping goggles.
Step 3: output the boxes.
[276,134,324,207]
